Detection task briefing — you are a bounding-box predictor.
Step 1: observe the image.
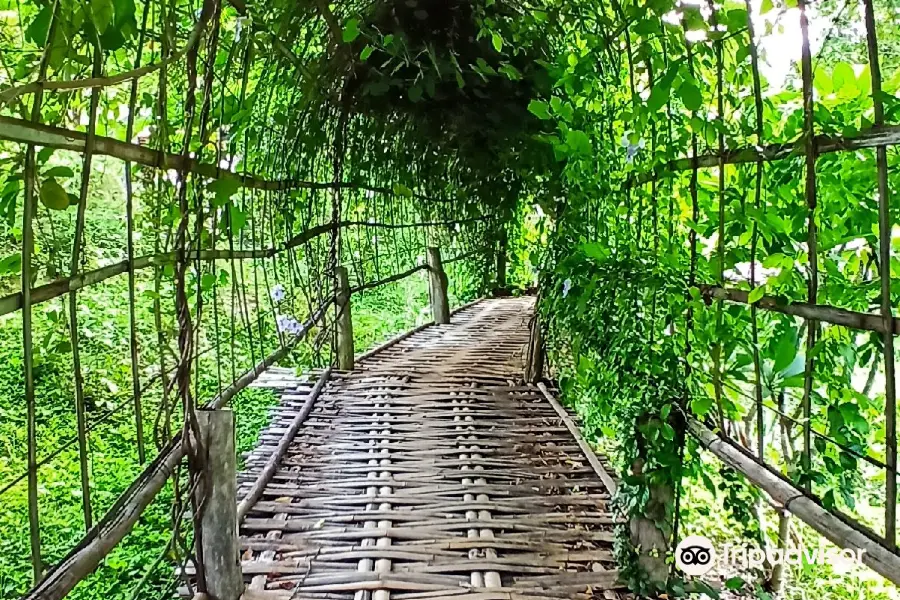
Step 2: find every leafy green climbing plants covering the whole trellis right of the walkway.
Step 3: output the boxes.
[529,1,900,591]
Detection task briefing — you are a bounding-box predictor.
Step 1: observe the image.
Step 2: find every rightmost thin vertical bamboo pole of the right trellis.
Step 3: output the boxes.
[863,0,897,548]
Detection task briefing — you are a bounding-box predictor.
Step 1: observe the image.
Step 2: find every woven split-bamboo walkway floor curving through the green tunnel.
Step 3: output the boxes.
[239,298,617,600]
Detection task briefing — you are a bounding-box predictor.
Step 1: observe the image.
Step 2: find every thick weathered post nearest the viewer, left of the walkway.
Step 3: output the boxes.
[197,409,244,600]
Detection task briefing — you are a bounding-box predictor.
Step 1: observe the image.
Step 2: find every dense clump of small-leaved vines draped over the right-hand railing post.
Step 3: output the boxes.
[542,237,689,593]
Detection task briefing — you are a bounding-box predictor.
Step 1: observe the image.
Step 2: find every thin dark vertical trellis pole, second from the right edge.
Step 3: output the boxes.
[798,0,819,491]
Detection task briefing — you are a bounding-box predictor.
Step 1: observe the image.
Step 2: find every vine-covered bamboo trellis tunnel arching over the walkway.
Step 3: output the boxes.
[0,0,900,592]
